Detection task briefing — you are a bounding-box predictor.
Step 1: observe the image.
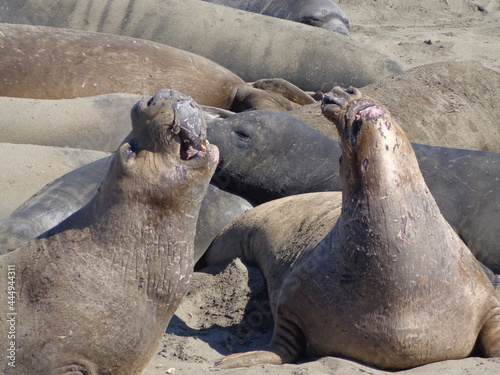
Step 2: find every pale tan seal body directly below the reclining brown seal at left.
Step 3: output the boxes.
[0,93,144,152]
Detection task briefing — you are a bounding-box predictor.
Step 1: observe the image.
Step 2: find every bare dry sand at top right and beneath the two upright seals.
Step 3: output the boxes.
[146,0,500,375]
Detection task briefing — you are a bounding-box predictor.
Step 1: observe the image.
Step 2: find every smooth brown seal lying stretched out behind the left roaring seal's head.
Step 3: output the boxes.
[0,24,314,110]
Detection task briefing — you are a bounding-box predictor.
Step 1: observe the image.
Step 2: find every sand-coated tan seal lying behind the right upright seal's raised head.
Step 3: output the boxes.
[289,61,500,156]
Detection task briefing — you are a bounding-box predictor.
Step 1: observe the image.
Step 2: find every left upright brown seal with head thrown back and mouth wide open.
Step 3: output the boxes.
[0,90,218,374]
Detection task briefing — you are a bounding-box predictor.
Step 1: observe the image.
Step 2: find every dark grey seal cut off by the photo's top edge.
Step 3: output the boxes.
[203,0,349,35]
